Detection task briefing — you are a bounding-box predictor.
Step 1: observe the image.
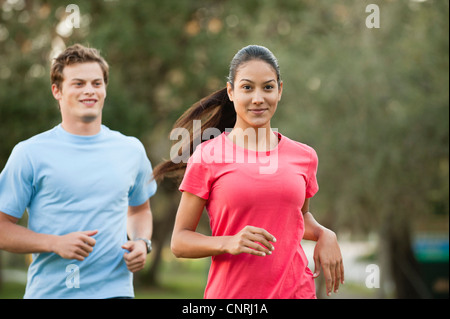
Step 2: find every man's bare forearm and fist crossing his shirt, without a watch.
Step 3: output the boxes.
[0,212,97,261]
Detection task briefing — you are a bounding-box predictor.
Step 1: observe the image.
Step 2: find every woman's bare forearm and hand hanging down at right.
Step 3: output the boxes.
[302,198,344,296]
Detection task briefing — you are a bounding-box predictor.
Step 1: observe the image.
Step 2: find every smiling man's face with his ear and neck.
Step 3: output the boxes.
[52,62,106,124]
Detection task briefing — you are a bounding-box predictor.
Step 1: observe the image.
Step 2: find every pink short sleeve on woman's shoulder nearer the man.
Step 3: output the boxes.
[179,147,212,199]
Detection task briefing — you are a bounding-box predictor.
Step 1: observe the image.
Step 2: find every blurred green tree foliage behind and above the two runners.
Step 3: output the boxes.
[0,0,449,232]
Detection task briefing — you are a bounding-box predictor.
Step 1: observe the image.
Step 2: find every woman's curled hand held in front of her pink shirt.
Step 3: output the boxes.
[224,226,276,256]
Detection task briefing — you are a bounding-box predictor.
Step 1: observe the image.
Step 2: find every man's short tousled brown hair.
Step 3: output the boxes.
[50,44,109,90]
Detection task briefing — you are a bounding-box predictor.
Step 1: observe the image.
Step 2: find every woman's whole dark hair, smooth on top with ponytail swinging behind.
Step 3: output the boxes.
[153,45,281,181]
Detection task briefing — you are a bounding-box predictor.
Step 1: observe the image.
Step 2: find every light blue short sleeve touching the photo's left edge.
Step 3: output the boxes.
[0,143,33,218]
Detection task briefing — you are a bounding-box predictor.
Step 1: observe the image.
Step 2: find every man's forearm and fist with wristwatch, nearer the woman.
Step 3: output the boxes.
[122,200,153,272]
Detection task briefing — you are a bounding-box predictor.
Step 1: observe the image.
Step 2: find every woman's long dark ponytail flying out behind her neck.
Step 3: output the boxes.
[153,87,236,181]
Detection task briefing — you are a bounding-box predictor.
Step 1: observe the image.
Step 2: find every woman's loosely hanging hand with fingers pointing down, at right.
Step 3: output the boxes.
[313,229,344,296]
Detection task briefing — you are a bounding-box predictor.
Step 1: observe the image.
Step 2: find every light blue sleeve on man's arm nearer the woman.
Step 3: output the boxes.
[128,142,157,206]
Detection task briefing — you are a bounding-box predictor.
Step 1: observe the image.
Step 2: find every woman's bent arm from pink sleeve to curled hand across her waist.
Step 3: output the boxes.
[171,192,275,258]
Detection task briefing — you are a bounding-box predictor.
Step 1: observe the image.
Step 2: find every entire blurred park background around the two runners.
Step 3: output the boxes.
[0,0,449,298]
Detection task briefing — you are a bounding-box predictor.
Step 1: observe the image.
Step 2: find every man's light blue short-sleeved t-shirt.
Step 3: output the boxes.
[0,125,156,299]
